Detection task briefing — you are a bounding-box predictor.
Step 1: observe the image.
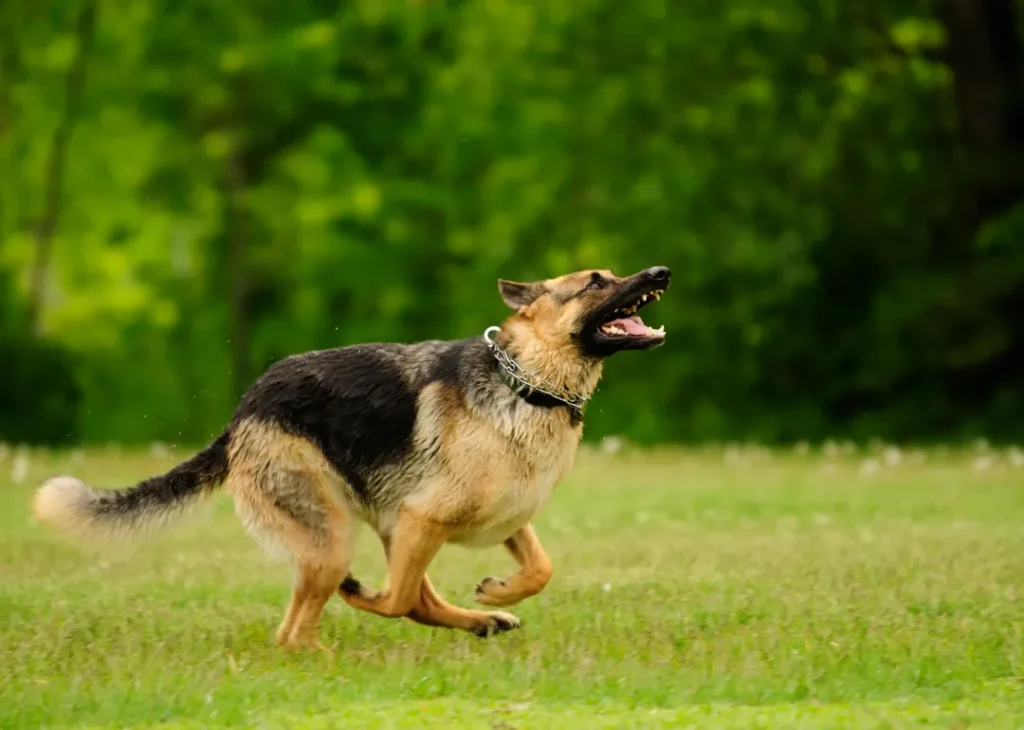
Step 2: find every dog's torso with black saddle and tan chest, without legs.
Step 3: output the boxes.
[228,338,580,542]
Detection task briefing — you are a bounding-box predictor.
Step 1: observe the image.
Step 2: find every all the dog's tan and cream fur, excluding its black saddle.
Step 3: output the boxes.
[34,264,663,647]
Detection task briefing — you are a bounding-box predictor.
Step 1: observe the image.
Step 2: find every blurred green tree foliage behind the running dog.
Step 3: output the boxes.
[0,0,1024,441]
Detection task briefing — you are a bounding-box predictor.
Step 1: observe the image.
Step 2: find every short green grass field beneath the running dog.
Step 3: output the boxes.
[0,442,1024,730]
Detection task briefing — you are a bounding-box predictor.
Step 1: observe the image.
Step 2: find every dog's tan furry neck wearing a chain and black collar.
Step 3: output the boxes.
[498,316,604,398]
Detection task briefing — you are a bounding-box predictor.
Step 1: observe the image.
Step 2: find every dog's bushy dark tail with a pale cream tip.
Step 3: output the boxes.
[32,432,230,542]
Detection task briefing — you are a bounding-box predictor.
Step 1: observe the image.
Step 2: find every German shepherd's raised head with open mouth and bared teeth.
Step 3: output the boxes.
[498,266,671,358]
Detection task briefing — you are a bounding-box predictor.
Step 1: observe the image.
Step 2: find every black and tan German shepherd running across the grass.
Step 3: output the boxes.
[33,266,670,647]
